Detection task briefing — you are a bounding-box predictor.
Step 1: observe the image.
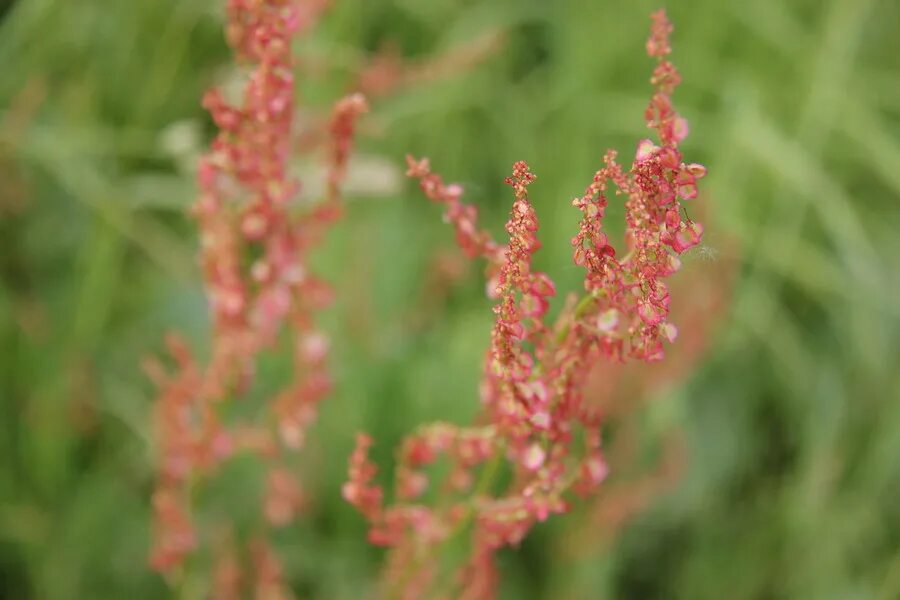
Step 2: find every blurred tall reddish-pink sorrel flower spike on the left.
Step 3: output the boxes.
[151,0,366,598]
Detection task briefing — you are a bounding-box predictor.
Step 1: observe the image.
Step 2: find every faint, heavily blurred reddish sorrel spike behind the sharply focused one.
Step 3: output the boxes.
[553,245,737,564]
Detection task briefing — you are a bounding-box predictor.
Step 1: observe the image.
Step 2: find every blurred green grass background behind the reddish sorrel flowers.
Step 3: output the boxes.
[0,0,900,599]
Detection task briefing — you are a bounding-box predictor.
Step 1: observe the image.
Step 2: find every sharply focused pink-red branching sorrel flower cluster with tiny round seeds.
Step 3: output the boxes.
[343,11,705,599]
